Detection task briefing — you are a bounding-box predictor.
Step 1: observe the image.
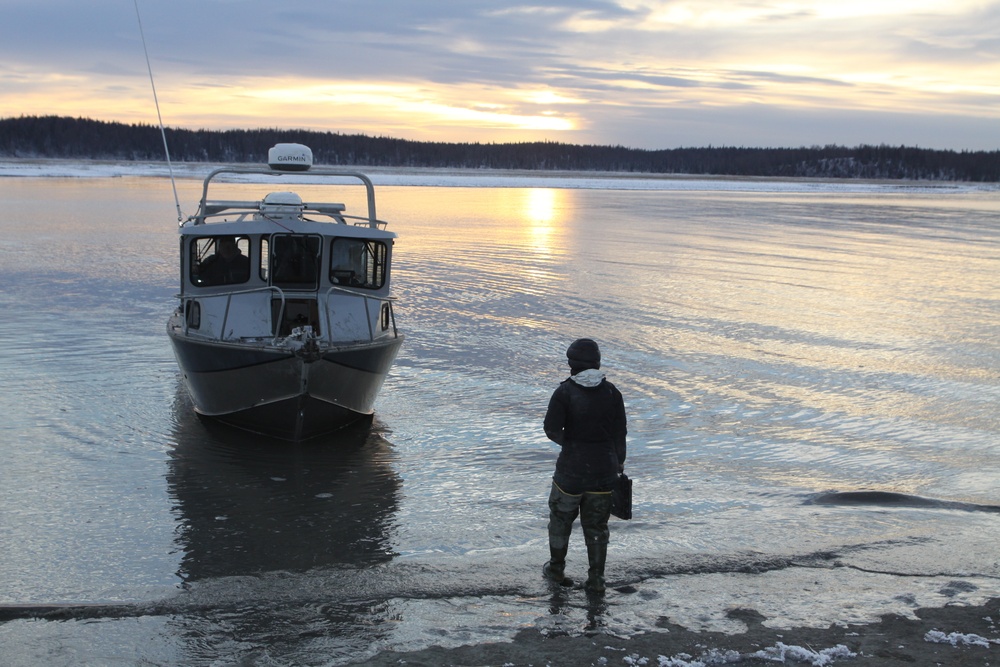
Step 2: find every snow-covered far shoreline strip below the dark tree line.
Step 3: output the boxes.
[0,158,1000,195]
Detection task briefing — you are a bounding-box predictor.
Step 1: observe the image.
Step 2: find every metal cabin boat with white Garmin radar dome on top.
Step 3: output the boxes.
[167,144,404,441]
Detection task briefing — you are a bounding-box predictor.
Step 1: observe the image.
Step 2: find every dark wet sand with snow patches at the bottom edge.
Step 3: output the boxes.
[354,599,1000,667]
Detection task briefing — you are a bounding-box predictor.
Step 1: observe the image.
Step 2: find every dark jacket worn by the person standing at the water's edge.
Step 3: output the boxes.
[544,370,628,494]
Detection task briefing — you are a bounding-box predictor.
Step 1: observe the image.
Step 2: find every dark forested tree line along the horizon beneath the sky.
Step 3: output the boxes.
[0,116,1000,182]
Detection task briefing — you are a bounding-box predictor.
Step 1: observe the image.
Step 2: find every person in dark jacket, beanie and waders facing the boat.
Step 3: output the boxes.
[542,338,628,594]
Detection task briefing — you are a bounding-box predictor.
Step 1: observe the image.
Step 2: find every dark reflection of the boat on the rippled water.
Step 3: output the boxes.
[166,395,401,581]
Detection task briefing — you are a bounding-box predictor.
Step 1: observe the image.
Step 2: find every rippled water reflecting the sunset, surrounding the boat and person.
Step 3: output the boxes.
[0,170,1000,665]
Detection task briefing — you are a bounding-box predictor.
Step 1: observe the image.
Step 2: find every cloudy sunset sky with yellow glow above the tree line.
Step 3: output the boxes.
[0,0,1000,151]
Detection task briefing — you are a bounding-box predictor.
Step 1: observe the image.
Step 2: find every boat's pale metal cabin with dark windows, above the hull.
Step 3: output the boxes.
[179,170,396,345]
